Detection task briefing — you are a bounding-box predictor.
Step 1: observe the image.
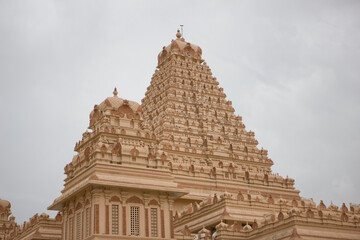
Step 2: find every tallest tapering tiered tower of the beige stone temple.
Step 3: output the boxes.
[142,31,299,220]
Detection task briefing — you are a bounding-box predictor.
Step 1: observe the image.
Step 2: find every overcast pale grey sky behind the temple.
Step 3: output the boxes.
[0,0,360,223]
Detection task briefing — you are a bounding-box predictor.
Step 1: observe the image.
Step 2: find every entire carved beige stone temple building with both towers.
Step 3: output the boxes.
[1,32,360,240]
